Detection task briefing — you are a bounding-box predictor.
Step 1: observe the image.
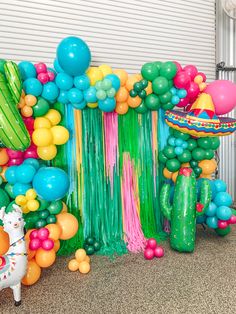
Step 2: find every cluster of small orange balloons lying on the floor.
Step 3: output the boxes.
[68,249,91,274]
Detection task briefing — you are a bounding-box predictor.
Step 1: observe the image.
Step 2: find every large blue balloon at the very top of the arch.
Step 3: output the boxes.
[57,36,91,76]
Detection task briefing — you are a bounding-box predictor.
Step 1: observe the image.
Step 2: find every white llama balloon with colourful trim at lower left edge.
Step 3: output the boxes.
[0,205,27,306]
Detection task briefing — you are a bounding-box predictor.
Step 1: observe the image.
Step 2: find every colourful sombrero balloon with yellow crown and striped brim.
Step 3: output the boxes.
[165,93,236,137]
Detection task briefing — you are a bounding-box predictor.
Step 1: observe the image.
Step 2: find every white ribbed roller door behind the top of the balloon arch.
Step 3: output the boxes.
[0,0,215,80]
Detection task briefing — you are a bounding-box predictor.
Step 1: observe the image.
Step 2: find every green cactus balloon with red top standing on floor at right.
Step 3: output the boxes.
[160,168,211,252]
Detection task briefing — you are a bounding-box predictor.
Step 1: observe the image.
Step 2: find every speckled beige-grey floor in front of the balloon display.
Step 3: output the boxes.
[0,228,236,314]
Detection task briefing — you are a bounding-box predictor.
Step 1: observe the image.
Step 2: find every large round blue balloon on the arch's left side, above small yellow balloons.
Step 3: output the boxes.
[33,167,70,202]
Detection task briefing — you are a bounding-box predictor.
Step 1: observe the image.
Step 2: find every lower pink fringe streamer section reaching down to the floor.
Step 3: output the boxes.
[122,155,146,253]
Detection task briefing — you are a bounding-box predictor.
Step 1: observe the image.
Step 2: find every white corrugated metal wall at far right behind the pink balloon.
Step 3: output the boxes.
[216,1,236,200]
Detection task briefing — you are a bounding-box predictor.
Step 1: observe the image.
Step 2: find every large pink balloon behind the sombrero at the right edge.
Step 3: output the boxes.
[204,80,236,115]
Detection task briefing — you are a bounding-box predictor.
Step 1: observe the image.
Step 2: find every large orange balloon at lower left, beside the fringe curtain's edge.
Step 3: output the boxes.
[57,213,79,240]
